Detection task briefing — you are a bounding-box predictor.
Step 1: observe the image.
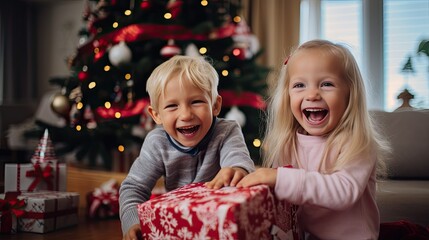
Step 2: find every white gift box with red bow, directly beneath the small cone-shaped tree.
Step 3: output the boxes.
[4,160,67,192]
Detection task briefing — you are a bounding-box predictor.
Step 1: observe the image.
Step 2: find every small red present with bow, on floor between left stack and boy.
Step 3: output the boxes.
[86,179,119,219]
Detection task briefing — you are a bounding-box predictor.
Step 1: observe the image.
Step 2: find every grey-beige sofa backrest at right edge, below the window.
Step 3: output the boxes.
[371,110,429,179]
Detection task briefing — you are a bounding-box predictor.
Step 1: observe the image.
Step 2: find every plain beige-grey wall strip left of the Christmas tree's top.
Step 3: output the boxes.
[37,0,85,96]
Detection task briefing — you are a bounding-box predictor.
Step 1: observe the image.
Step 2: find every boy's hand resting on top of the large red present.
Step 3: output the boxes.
[205,167,247,189]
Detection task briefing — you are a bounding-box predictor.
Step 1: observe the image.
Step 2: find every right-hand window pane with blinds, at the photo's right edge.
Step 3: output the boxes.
[384,0,429,110]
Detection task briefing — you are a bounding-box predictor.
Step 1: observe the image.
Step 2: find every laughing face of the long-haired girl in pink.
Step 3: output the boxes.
[287,49,349,136]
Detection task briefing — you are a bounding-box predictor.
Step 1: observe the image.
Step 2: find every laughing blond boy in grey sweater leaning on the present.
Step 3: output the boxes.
[119,56,255,240]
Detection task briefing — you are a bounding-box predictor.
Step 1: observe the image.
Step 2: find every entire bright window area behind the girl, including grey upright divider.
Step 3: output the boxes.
[301,0,429,111]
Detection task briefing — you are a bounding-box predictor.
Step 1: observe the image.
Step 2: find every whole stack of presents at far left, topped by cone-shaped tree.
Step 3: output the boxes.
[0,131,79,233]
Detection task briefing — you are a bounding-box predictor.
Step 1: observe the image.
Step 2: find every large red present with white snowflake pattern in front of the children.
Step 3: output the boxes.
[138,183,296,239]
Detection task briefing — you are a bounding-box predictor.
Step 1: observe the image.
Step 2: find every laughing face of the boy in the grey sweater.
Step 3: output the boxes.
[148,77,222,147]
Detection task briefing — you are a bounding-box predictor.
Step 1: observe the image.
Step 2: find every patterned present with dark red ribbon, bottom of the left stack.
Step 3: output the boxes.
[0,191,79,233]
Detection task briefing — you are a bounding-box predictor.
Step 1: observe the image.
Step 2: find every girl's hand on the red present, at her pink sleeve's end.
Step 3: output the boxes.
[237,168,277,187]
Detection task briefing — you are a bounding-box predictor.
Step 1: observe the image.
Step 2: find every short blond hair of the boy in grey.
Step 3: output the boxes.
[146,55,219,110]
